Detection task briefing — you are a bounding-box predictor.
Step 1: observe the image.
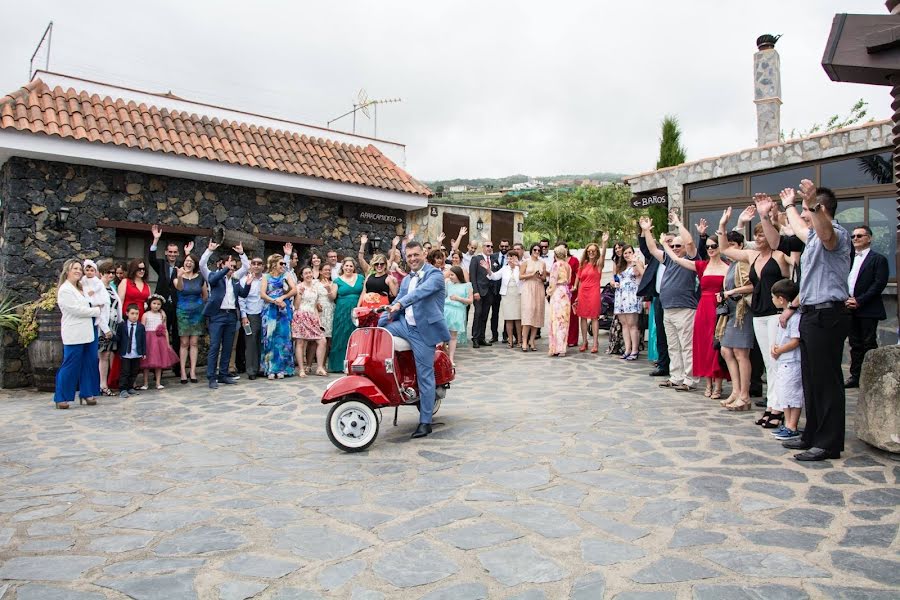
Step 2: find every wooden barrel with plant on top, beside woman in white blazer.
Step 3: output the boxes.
[16,285,63,392]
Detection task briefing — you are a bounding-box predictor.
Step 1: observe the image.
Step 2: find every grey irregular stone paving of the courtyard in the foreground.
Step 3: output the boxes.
[0,346,900,600]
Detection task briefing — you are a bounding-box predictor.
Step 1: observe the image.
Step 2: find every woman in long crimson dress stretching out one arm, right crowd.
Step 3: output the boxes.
[664,238,729,399]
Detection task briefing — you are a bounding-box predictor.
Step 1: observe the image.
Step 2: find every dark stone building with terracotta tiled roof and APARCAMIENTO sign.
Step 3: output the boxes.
[0,73,431,387]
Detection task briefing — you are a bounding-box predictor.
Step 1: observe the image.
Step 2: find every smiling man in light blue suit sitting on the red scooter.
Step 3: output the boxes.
[378,241,450,438]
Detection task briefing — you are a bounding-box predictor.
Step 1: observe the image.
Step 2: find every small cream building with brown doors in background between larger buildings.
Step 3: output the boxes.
[409,202,525,250]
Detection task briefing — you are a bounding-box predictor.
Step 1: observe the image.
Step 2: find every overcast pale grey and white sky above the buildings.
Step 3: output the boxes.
[0,0,891,180]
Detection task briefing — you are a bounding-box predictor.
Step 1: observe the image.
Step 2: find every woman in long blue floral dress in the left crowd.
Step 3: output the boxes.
[259,254,302,379]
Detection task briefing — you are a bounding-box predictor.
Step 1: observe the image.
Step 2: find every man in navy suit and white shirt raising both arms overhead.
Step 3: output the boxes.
[200,240,250,390]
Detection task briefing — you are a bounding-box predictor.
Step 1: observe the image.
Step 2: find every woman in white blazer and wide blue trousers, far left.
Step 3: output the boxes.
[53,258,100,408]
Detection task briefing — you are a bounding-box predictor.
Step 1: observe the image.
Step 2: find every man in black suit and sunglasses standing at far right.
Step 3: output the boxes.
[844,225,888,388]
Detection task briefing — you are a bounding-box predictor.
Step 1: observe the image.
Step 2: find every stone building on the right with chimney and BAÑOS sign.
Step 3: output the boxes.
[625,36,897,344]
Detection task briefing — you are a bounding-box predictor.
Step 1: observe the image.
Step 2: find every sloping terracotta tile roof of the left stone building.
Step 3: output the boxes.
[0,79,431,196]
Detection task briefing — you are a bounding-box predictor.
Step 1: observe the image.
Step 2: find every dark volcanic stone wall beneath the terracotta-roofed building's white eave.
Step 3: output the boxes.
[0,158,406,387]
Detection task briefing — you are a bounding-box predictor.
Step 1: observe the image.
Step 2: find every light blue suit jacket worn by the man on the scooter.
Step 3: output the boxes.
[378,263,450,346]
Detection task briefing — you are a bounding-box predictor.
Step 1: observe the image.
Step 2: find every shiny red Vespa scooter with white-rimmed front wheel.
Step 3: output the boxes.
[322,306,456,452]
